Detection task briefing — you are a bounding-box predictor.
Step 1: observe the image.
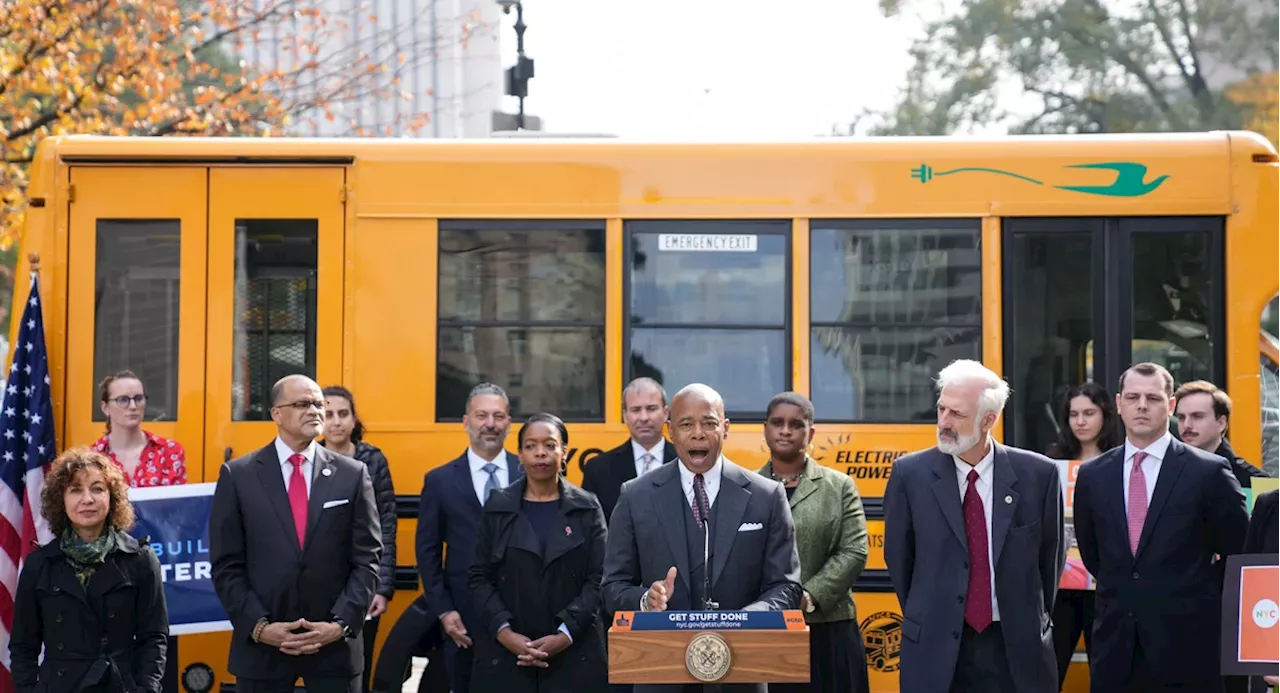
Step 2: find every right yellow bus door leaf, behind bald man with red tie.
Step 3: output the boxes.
[205,167,346,482]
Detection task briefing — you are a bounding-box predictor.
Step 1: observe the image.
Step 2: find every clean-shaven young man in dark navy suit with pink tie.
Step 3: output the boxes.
[1075,364,1249,693]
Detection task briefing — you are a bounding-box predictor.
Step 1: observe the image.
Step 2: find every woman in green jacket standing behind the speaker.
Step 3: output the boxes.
[760,392,870,693]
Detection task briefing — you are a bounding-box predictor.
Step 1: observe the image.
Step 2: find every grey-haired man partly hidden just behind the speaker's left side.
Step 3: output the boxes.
[582,378,676,523]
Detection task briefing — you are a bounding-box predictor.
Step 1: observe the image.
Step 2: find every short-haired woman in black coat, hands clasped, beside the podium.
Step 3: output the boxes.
[468,414,609,693]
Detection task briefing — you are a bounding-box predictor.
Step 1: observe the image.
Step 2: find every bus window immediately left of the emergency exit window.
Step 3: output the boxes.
[435,220,605,421]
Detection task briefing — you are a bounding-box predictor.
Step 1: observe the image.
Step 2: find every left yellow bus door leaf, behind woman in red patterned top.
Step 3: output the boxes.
[59,165,207,471]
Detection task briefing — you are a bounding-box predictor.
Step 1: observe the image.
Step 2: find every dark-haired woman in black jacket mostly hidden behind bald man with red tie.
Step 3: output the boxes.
[321,386,398,693]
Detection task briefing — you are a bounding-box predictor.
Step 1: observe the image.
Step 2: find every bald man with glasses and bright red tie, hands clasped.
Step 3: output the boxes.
[209,375,381,693]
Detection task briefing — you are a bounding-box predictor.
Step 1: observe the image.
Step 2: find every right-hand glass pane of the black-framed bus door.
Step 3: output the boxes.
[1132,231,1221,384]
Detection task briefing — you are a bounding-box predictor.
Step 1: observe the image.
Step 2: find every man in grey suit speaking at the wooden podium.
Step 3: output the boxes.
[603,384,801,693]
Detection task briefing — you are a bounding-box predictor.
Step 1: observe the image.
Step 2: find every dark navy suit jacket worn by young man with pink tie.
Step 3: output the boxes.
[1074,438,1249,692]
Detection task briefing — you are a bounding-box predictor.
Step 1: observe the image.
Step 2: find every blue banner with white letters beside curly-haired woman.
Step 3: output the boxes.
[129,483,232,635]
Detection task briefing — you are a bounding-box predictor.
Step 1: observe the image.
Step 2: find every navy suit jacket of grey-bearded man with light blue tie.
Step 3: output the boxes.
[415,451,525,627]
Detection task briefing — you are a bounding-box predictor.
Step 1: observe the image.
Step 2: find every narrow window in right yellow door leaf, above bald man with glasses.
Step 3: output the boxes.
[232,219,320,421]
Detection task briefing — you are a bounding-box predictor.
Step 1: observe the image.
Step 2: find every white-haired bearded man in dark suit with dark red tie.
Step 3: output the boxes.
[884,360,1066,693]
